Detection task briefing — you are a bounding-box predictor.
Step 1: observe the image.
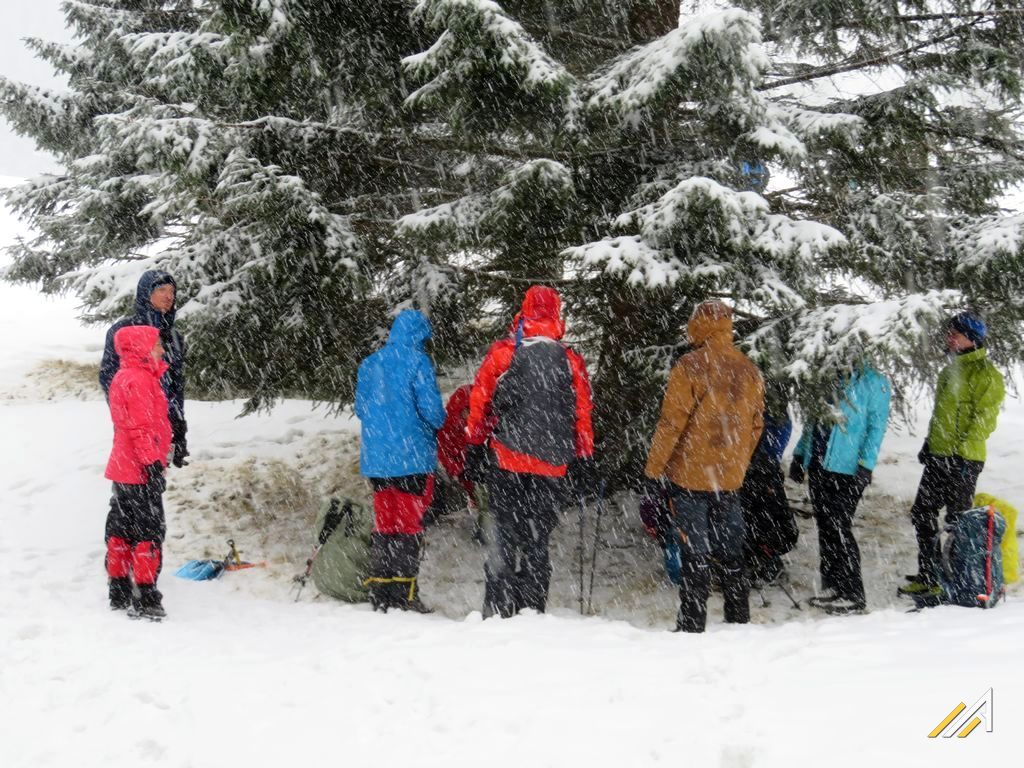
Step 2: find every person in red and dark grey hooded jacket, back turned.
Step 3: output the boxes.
[464,286,594,616]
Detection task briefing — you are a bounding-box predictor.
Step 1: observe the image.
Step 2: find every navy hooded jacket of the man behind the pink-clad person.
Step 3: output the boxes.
[99,269,185,440]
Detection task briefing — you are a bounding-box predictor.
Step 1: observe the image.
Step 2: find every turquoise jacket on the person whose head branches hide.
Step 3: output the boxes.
[793,368,892,475]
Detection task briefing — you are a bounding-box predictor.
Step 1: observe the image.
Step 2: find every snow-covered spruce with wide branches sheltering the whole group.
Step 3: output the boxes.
[4,0,1024,476]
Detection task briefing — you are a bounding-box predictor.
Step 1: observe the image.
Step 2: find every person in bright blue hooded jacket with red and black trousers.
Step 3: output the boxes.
[355,309,445,612]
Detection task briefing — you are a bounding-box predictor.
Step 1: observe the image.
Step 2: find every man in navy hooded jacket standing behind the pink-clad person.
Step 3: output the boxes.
[99,269,188,468]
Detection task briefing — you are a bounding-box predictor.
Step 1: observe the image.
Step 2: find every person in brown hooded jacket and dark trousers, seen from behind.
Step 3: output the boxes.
[645,301,764,632]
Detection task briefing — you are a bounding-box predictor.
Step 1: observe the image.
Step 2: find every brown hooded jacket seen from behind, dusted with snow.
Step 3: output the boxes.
[646,302,764,490]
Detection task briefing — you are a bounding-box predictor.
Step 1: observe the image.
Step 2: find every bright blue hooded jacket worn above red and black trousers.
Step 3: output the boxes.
[355,309,444,477]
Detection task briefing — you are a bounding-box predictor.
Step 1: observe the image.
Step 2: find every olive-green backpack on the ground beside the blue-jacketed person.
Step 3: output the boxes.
[310,499,374,603]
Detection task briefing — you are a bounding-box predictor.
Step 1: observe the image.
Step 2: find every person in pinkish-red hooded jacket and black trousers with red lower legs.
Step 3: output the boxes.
[104,326,172,620]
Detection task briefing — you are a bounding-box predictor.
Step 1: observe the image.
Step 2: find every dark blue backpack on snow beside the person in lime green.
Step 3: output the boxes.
[941,505,1007,608]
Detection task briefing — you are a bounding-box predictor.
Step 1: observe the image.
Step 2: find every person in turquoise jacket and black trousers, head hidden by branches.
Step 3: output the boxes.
[790,365,892,613]
